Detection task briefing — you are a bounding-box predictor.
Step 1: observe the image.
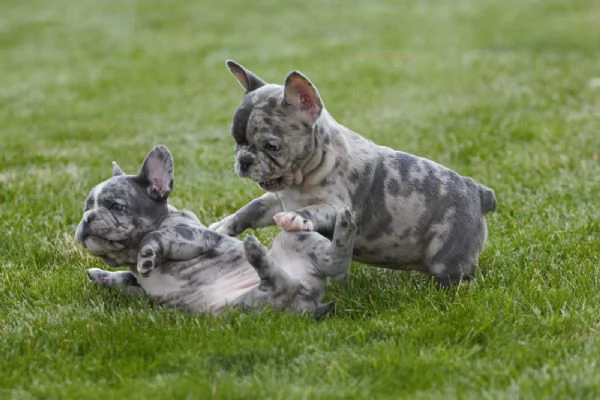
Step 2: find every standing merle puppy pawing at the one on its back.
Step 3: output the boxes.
[210,61,496,285]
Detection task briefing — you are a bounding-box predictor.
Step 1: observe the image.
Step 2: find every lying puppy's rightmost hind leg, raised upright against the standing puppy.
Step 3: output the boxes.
[318,207,356,282]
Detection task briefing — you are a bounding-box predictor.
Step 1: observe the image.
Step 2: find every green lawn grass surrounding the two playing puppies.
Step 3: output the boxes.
[0,0,600,399]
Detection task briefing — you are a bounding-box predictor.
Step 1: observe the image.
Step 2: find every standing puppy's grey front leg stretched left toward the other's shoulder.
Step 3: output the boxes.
[208,193,283,236]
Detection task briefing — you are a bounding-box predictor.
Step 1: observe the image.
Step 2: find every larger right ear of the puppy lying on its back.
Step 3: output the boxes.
[138,145,173,200]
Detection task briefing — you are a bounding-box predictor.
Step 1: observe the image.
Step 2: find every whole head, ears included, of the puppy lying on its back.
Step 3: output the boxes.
[75,146,173,266]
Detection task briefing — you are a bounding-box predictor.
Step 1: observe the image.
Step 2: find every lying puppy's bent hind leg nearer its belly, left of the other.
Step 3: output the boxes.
[244,236,300,310]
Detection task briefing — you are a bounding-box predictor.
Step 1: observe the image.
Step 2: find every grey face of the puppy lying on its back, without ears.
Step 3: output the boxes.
[76,175,168,266]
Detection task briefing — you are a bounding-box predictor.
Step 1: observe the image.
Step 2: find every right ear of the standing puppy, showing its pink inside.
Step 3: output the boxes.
[283,71,323,124]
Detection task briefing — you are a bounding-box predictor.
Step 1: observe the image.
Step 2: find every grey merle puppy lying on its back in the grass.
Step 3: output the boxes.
[76,146,356,316]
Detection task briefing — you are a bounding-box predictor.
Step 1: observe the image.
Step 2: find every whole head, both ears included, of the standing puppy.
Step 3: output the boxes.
[227,61,323,191]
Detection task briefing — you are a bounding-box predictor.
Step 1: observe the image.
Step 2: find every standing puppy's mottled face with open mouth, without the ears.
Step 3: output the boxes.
[232,85,316,192]
